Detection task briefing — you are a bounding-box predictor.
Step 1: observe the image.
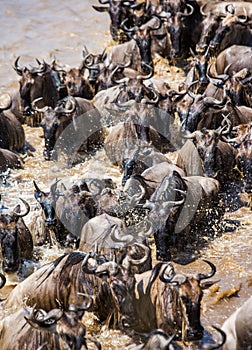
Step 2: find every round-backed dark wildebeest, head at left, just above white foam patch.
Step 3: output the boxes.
[41,96,104,165]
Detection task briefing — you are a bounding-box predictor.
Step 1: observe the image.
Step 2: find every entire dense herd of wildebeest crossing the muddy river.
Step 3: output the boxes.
[0,0,252,350]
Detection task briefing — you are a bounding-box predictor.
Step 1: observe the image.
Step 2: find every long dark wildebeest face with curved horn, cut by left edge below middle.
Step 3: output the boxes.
[0,199,30,273]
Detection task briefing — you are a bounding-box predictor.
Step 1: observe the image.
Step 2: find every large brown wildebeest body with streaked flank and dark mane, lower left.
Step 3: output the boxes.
[3,252,113,321]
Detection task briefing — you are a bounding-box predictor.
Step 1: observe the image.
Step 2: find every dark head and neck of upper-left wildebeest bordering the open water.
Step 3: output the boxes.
[14,56,58,115]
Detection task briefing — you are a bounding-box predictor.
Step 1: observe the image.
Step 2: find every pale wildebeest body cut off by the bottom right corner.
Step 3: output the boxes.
[222,297,252,350]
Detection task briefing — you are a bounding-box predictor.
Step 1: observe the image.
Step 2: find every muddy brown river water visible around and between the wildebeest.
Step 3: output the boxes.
[0,0,252,350]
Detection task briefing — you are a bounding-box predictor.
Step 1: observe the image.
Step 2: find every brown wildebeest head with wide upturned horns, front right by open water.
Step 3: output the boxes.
[150,260,216,341]
